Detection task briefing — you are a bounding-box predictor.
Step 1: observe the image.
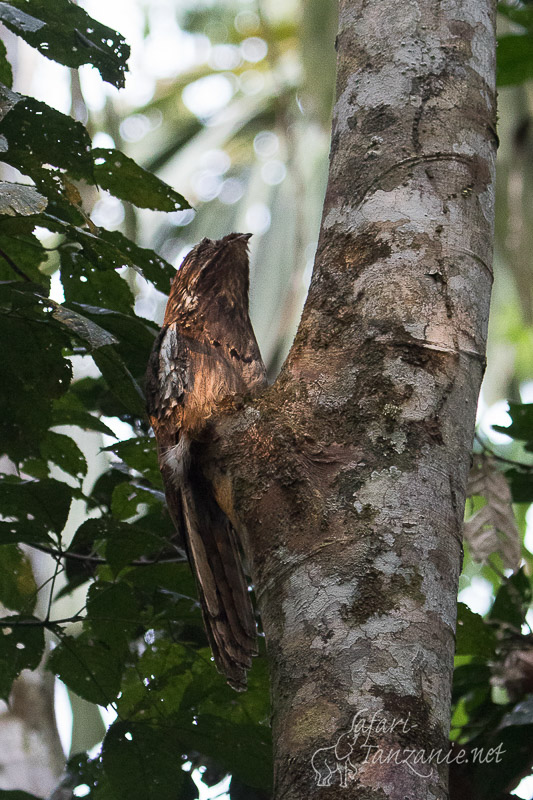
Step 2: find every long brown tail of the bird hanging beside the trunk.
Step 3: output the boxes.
[180,474,257,690]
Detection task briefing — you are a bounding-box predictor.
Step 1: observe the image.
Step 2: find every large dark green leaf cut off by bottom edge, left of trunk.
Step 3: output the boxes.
[102,721,186,800]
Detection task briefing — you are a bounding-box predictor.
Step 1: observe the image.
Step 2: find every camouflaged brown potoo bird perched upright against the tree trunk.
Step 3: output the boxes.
[145,233,267,691]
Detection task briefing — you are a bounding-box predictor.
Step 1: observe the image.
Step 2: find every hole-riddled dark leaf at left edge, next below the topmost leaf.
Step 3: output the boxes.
[0,87,94,183]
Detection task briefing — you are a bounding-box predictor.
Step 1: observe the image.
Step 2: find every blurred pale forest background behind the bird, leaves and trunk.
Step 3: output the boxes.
[0,0,533,800]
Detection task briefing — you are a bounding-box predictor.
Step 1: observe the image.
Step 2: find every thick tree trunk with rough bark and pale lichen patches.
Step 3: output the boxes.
[207,0,496,800]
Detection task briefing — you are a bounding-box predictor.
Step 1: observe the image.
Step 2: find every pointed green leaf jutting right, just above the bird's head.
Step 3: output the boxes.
[93,148,190,211]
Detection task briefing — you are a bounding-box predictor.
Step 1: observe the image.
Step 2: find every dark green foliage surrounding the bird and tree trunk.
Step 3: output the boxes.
[0,0,533,800]
